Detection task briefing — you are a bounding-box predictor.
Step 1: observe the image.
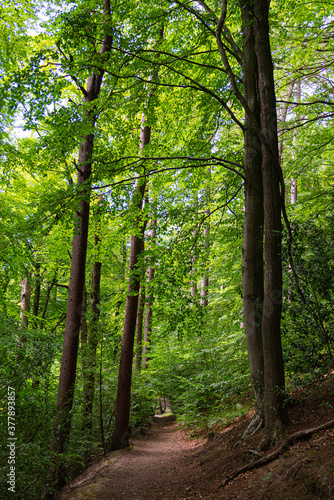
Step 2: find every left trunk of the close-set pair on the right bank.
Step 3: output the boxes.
[241,2,264,437]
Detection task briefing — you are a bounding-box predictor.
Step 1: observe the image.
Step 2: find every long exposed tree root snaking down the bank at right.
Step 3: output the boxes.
[217,420,334,489]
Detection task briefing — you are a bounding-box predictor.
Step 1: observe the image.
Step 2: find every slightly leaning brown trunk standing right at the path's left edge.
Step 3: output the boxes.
[110,179,145,450]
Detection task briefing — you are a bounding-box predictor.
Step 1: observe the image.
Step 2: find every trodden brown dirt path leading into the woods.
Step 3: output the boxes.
[60,416,205,500]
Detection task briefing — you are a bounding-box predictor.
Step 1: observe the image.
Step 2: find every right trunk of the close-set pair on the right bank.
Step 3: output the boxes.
[254,0,288,448]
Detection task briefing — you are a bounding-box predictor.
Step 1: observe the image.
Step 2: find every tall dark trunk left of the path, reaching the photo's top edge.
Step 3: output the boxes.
[46,0,112,495]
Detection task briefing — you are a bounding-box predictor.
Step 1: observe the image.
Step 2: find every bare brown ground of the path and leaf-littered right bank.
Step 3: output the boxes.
[60,376,334,500]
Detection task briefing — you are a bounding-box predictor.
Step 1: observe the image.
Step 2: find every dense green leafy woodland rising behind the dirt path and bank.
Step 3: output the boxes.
[0,0,334,499]
